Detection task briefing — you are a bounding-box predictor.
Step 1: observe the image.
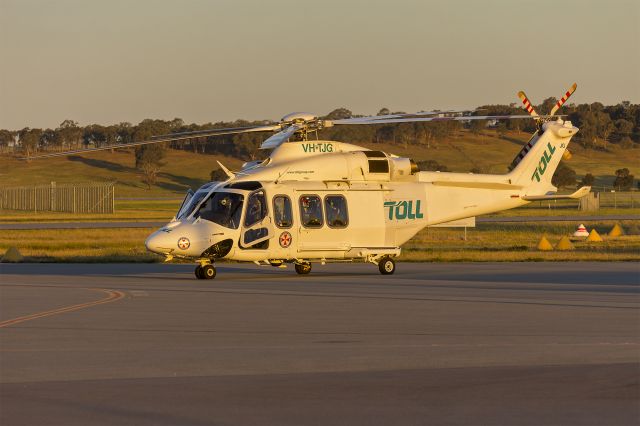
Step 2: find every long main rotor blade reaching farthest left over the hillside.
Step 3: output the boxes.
[22,124,281,160]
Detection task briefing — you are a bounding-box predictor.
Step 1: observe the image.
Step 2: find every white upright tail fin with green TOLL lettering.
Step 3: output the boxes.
[508,120,578,196]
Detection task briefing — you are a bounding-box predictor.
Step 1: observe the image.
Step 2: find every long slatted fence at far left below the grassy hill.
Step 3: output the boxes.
[0,182,115,213]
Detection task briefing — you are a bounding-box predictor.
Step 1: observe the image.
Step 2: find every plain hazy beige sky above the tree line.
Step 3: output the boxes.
[0,0,640,130]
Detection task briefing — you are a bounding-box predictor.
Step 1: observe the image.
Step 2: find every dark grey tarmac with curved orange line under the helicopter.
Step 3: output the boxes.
[0,262,640,425]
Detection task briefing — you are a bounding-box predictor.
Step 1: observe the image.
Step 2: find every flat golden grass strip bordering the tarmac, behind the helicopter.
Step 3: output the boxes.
[0,221,640,262]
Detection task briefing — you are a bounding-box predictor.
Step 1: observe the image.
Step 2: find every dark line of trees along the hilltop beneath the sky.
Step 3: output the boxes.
[0,98,640,156]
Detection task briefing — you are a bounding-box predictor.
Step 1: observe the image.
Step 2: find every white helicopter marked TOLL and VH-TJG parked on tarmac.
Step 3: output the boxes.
[32,84,590,279]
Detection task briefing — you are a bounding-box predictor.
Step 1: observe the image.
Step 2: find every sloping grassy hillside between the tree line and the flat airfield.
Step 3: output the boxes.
[0,130,640,198]
